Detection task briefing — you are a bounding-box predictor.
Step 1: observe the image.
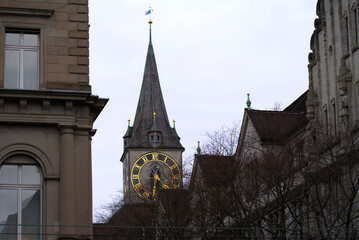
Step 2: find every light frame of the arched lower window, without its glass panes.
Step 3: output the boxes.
[0,162,44,240]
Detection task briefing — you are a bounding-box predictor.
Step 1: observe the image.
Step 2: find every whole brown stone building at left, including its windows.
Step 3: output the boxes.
[0,0,108,239]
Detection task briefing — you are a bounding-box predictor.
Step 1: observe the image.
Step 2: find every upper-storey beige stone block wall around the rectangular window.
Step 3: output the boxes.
[0,0,91,91]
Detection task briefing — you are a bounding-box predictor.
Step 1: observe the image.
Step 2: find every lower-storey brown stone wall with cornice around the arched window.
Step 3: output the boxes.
[0,89,107,239]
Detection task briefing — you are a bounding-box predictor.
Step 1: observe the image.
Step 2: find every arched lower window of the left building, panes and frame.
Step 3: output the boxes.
[0,164,42,240]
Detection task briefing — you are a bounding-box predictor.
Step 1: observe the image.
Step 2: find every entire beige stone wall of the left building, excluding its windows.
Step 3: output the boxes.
[0,0,108,239]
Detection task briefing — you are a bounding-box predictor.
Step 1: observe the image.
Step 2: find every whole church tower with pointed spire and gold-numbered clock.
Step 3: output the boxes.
[121,20,184,204]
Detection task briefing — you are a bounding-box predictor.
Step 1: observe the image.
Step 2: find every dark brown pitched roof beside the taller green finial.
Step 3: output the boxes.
[246,109,308,142]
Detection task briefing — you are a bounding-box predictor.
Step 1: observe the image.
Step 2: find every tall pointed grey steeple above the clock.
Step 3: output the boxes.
[126,20,183,149]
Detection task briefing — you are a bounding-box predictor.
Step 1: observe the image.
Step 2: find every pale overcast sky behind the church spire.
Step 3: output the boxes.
[90,0,316,218]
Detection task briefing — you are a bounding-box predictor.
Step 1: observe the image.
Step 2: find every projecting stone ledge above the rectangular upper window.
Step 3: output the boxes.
[0,7,55,18]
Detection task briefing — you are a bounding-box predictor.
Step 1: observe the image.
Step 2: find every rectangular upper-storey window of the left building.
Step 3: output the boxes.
[5,30,40,89]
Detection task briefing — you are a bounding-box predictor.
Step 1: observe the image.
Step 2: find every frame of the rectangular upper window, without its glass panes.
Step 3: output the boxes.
[3,28,41,90]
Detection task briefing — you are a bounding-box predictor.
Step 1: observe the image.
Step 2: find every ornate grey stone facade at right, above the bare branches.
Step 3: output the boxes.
[307,0,359,136]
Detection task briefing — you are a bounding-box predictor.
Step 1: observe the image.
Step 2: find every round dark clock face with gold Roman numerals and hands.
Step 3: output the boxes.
[131,152,181,201]
